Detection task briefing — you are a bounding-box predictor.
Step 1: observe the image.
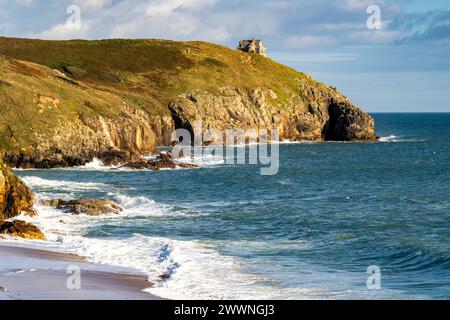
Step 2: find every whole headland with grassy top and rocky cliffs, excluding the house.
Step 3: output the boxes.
[0,38,376,168]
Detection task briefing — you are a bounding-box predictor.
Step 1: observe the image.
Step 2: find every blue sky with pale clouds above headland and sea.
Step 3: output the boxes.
[0,0,450,112]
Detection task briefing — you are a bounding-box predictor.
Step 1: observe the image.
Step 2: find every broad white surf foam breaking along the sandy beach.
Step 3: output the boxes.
[12,185,318,299]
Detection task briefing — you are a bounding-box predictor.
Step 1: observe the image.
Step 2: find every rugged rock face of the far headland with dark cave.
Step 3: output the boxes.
[170,86,377,143]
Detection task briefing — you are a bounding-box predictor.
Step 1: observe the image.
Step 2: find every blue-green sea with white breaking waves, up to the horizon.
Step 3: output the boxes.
[12,114,450,299]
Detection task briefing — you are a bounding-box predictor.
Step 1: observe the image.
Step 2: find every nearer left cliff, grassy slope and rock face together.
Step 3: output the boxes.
[0,52,173,168]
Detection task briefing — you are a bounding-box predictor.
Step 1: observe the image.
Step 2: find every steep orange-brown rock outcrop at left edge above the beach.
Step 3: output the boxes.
[0,159,36,219]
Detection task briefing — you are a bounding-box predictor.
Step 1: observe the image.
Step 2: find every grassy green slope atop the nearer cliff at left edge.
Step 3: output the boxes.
[0,52,126,150]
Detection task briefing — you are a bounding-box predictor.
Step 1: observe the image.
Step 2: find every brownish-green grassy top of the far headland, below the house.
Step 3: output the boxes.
[0,38,312,112]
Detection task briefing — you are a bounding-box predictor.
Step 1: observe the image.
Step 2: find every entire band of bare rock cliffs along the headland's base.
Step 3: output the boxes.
[5,84,377,170]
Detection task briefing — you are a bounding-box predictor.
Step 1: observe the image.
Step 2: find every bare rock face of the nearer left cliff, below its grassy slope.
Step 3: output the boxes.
[4,105,173,169]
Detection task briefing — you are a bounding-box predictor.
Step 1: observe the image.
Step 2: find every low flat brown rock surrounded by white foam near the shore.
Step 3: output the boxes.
[40,199,123,216]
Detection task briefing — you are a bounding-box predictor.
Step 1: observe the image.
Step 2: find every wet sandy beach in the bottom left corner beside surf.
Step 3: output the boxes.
[0,244,159,300]
